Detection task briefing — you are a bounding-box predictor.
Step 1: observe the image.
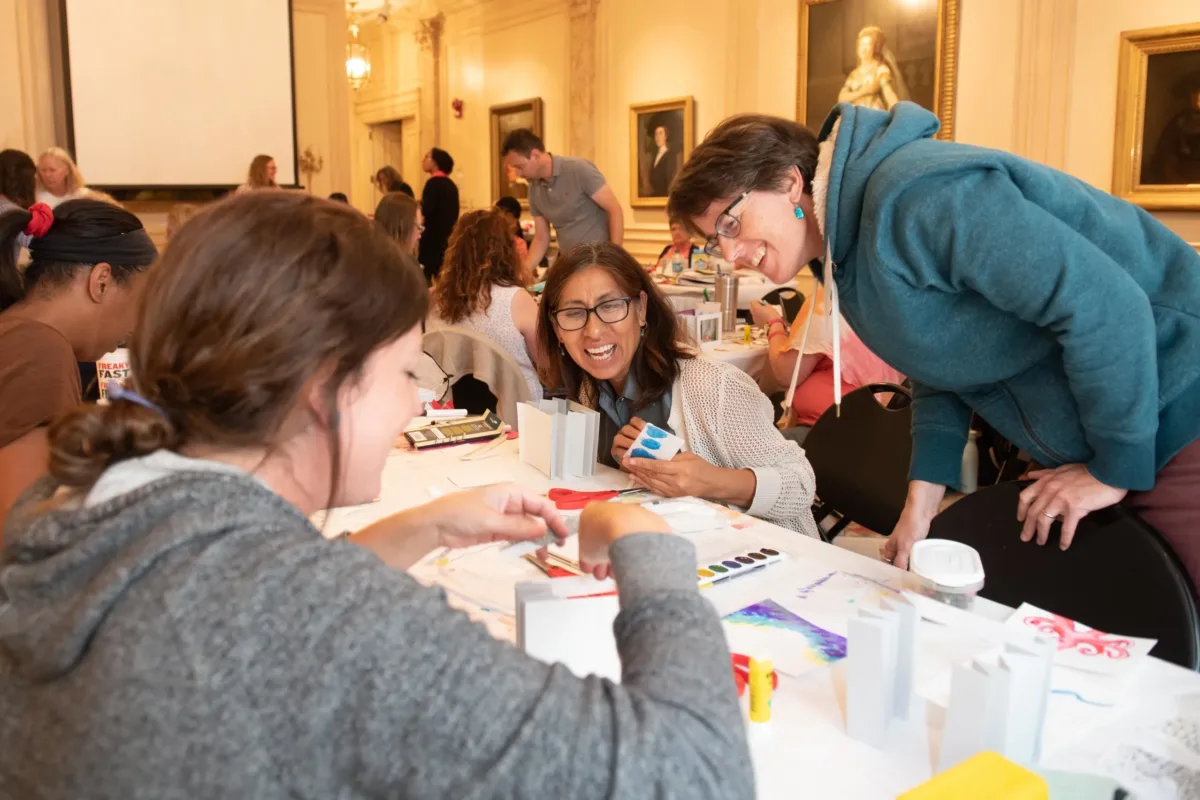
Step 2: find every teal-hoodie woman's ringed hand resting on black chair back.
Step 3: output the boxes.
[1016,464,1128,549]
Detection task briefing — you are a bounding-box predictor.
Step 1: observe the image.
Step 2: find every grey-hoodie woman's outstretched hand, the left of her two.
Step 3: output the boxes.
[414,483,568,548]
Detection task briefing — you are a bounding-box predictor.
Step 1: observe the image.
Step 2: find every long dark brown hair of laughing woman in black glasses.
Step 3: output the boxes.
[538,242,692,410]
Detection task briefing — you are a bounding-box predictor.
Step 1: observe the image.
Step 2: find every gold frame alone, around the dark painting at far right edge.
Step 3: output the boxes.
[1112,24,1200,211]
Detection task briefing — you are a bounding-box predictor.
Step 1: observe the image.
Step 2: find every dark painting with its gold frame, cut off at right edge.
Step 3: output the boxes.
[1112,23,1200,210]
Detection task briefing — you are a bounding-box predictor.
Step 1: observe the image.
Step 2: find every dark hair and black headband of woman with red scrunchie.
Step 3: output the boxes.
[0,198,157,311]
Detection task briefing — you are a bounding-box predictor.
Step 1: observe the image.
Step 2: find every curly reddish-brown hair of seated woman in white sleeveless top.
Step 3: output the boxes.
[433,210,523,324]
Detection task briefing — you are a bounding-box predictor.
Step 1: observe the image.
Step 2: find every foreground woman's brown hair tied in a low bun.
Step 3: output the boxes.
[50,192,428,487]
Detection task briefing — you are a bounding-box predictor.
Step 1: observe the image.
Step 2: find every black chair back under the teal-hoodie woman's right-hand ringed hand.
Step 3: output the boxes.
[929,481,1200,670]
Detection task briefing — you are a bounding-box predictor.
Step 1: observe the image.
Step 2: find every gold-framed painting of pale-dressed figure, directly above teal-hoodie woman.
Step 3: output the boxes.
[796,0,959,139]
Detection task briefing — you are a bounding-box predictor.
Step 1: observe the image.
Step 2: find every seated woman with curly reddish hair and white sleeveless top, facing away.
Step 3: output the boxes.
[428,210,542,401]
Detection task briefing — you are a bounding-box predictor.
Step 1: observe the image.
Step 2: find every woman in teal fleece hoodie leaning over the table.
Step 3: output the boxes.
[668,103,1200,583]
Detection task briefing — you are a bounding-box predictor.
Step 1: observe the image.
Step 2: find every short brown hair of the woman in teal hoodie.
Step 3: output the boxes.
[667,114,817,235]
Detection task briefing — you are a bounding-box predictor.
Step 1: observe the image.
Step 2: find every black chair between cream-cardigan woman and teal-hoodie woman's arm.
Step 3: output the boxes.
[804,384,912,540]
